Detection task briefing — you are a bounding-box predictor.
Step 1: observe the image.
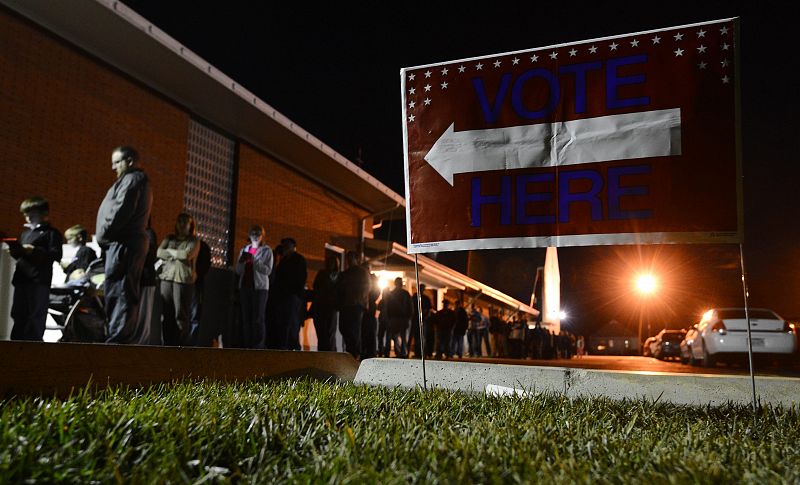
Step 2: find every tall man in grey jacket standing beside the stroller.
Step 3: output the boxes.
[96,146,153,343]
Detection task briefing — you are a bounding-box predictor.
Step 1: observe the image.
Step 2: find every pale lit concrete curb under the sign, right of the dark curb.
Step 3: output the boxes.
[355,359,800,407]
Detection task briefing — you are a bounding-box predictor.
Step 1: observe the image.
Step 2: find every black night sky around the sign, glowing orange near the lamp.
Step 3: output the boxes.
[124,0,800,333]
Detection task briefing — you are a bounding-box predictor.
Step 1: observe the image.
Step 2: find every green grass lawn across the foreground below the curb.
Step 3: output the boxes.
[0,380,800,483]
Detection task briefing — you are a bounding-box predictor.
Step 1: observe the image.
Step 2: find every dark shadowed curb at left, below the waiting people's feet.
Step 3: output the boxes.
[0,341,358,396]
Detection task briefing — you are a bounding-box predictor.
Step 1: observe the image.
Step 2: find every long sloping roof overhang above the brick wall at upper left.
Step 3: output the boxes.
[0,0,405,215]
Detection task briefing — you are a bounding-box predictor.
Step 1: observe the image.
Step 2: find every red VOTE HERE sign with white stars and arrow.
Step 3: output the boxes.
[401,19,741,253]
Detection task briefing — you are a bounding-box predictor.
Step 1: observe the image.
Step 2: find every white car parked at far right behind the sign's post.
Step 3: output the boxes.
[681,308,795,367]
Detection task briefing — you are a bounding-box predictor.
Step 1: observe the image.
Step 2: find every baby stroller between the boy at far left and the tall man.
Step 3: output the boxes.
[48,258,106,342]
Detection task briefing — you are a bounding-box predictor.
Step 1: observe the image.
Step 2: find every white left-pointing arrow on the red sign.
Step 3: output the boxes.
[425,108,681,185]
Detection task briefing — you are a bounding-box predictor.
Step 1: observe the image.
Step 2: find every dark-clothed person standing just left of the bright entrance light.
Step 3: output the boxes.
[337,251,371,358]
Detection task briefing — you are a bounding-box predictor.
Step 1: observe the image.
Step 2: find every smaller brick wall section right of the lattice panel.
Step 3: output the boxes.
[234,143,367,286]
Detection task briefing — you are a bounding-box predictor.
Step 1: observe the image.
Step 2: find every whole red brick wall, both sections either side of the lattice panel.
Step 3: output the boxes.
[0,7,367,284]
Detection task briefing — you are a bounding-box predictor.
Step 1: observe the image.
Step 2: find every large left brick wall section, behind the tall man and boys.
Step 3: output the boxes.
[0,7,188,246]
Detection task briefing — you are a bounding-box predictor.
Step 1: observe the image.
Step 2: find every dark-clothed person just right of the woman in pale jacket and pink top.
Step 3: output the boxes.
[269,237,308,350]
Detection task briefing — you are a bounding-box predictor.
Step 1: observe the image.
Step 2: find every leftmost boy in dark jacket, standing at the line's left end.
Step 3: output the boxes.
[8,197,63,341]
